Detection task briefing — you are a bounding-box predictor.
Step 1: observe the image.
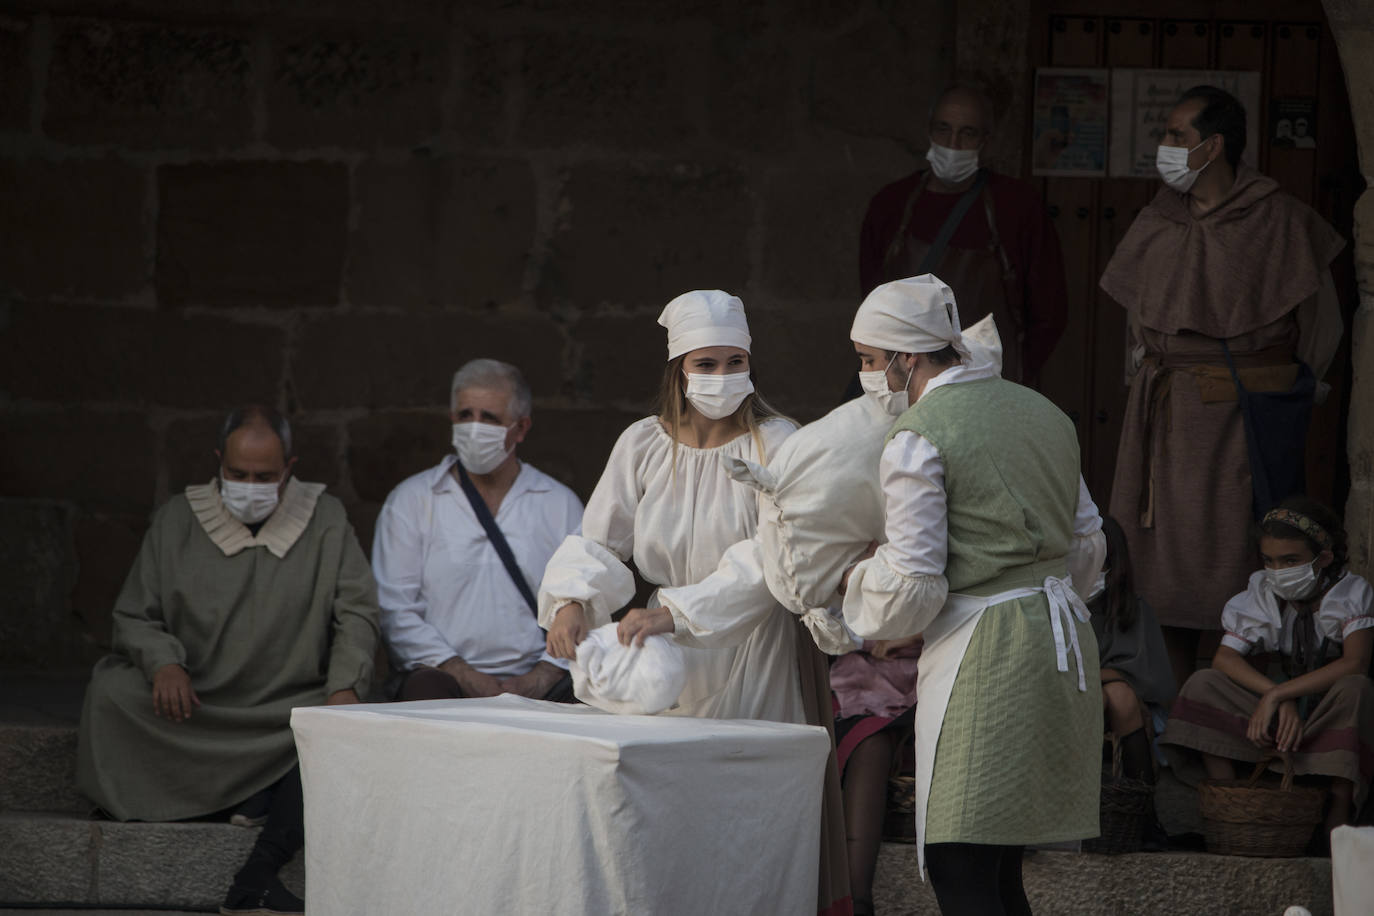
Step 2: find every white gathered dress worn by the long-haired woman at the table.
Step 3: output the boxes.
[539,416,804,722]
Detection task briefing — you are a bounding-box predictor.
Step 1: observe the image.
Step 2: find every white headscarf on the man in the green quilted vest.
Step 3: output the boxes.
[849,273,969,361]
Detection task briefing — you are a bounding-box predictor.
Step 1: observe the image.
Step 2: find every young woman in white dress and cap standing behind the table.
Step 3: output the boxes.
[539,290,805,722]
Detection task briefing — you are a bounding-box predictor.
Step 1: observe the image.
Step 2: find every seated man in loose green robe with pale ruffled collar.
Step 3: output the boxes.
[77,407,378,913]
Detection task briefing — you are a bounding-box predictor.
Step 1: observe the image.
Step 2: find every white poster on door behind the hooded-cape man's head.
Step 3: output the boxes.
[1109,67,1264,179]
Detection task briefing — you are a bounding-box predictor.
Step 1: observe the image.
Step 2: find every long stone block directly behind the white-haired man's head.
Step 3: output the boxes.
[291,312,563,411]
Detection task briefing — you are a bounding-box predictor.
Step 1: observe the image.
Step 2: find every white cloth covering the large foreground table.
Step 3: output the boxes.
[291,695,830,916]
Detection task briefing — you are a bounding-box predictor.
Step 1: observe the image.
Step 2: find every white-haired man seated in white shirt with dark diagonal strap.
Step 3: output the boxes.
[372,360,583,700]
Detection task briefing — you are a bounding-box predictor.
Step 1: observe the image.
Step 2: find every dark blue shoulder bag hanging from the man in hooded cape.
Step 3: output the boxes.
[1221,341,1316,522]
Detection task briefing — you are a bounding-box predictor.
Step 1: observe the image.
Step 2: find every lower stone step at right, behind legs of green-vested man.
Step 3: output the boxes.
[874,843,1333,916]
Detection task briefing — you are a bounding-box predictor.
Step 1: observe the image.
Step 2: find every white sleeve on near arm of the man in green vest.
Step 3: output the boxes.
[844,431,949,640]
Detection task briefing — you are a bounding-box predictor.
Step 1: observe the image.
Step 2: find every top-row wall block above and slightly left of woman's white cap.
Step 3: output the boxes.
[518,32,699,150]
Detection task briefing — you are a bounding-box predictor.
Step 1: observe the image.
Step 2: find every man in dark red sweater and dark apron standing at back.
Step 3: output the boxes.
[859,87,1068,386]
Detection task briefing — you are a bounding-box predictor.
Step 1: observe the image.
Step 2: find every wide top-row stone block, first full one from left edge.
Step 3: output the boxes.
[43,19,253,148]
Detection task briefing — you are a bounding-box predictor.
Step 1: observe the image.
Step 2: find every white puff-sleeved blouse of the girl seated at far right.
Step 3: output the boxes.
[1221,570,1374,655]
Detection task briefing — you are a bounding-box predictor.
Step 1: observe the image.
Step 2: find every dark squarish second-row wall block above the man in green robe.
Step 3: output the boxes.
[157,162,349,308]
